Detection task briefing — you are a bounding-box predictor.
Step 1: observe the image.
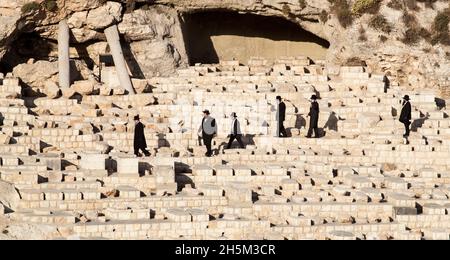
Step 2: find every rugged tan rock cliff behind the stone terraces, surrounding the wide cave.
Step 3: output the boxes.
[0,0,450,94]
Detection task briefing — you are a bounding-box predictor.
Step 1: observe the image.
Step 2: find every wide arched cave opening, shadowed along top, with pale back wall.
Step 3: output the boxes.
[182,11,330,65]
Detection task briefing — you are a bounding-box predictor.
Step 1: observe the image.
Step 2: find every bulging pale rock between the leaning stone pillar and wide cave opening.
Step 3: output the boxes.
[118,6,188,78]
